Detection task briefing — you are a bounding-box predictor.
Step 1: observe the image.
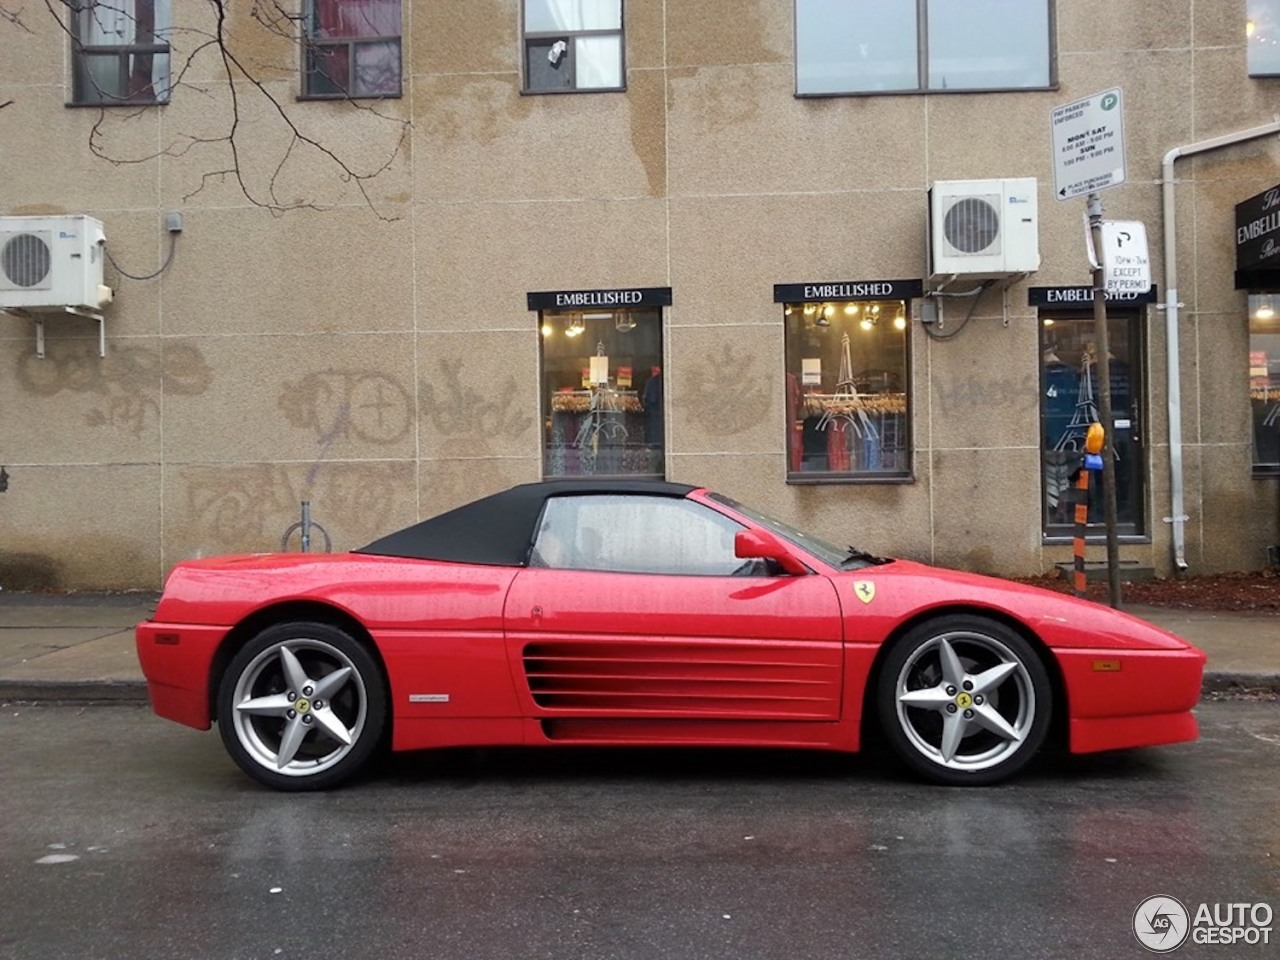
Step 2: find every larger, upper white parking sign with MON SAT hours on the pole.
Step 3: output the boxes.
[1050,87,1124,200]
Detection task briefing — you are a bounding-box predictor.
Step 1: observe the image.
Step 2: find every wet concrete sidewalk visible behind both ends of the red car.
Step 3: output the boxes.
[0,591,1280,701]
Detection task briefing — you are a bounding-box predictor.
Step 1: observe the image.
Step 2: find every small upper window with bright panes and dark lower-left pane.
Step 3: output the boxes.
[525,0,626,93]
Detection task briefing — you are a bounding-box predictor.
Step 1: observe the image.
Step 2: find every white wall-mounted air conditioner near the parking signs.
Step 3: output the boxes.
[929,177,1039,279]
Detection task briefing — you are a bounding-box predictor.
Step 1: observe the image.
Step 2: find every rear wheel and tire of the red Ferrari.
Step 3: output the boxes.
[218,623,387,791]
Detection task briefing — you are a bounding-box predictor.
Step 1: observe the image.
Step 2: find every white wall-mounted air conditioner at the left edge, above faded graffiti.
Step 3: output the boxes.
[0,215,111,312]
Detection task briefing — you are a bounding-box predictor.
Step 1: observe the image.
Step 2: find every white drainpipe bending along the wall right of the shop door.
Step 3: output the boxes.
[1160,120,1280,572]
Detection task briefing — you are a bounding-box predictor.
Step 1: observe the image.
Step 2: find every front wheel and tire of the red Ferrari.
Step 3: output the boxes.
[874,616,1053,786]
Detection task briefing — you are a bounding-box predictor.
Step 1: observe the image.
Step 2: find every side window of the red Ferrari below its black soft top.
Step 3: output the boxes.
[529,494,752,576]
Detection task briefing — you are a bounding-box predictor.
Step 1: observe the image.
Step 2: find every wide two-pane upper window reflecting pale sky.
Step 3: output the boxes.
[796,0,1053,96]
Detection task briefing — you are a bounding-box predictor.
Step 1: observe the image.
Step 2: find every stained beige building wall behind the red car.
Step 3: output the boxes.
[0,0,1280,589]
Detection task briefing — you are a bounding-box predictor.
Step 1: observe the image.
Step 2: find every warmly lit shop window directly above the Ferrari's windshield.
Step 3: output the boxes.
[783,300,911,480]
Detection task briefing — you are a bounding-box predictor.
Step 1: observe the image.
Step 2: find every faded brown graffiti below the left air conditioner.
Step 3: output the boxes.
[18,343,214,436]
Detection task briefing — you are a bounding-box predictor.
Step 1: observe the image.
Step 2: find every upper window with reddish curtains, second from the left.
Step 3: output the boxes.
[302,0,401,100]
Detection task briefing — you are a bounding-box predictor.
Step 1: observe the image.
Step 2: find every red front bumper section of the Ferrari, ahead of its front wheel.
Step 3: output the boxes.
[1057,646,1204,754]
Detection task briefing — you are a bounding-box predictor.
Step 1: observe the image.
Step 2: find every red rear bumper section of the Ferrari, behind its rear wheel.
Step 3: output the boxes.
[134,620,228,730]
